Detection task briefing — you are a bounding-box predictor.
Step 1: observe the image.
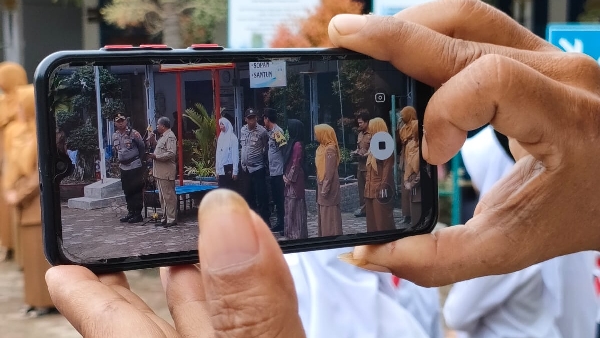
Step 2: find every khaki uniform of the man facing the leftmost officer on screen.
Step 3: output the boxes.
[152,129,177,223]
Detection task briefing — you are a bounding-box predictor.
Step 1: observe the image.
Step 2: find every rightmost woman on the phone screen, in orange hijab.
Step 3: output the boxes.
[398,106,419,223]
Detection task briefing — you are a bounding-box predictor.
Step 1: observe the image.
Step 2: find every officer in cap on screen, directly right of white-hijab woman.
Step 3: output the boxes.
[240,108,270,224]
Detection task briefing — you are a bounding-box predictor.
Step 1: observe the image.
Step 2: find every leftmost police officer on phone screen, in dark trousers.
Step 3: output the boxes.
[113,113,146,223]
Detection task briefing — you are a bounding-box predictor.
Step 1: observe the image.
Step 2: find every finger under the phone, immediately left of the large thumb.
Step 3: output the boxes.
[160,265,214,338]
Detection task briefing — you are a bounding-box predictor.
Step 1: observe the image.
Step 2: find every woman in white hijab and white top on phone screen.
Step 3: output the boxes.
[215,117,240,190]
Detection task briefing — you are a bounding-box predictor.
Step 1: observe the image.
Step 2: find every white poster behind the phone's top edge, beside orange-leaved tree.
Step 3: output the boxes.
[227,0,321,48]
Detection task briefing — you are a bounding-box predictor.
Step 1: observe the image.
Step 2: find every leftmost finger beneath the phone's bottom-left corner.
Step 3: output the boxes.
[46,265,176,337]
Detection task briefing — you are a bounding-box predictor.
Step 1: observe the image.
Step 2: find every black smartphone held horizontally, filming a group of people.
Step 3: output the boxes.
[34,45,438,273]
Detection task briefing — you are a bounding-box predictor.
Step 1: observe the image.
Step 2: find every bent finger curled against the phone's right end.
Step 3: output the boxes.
[422,55,592,166]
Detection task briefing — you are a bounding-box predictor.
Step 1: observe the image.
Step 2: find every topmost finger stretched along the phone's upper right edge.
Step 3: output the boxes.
[329,14,600,92]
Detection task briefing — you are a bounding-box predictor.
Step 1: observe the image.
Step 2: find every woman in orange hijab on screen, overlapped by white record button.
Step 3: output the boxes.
[365,117,396,232]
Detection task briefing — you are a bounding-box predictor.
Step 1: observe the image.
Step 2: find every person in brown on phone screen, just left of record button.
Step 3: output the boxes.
[352,109,371,217]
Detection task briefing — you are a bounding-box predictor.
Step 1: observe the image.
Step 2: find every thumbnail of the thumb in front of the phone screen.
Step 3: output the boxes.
[198,189,259,270]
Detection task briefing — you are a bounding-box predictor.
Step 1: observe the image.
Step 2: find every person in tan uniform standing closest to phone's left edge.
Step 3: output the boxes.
[3,86,54,308]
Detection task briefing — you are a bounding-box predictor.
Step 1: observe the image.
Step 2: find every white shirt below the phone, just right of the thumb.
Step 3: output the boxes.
[285,248,428,338]
